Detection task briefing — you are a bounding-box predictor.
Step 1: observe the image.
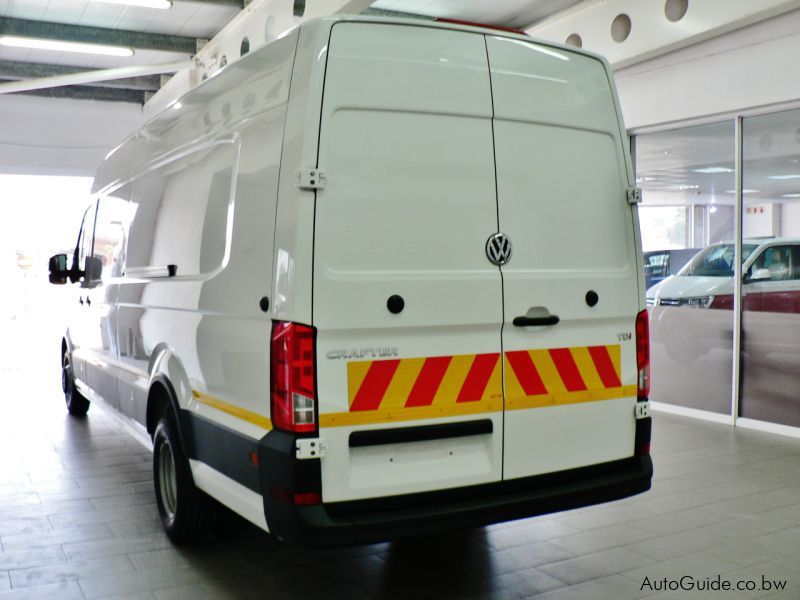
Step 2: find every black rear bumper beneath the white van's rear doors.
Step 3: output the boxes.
[265,455,653,546]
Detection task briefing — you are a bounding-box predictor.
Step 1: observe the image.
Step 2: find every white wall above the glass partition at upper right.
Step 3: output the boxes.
[615,10,800,129]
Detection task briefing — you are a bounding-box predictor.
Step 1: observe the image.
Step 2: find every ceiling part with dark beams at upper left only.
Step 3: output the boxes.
[0,0,243,104]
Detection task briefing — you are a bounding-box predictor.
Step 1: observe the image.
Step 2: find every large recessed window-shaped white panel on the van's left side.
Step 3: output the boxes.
[125,142,236,275]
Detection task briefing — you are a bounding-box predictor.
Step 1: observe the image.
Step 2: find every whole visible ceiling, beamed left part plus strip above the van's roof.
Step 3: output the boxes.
[0,0,580,104]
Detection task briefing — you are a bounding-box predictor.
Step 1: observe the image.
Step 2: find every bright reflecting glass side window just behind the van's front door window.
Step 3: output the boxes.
[92,184,132,281]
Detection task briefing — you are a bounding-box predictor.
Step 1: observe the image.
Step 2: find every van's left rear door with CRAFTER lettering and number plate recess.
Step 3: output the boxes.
[313,22,503,502]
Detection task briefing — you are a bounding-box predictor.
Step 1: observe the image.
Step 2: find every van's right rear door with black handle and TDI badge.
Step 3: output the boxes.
[486,36,638,479]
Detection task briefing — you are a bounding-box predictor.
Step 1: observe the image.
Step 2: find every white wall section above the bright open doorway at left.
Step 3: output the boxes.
[0,94,142,177]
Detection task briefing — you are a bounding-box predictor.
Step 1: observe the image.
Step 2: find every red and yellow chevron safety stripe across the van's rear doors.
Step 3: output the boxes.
[320,345,636,427]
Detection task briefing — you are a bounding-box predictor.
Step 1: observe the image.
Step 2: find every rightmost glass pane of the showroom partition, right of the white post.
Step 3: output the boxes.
[739,110,800,427]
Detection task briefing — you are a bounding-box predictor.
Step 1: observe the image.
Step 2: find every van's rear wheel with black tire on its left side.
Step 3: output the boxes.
[153,411,209,544]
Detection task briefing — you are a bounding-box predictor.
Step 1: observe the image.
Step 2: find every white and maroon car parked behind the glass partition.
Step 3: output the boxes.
[646,238,800,313]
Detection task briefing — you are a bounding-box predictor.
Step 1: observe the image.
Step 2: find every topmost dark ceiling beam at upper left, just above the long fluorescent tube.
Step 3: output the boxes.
[0,17,197,54]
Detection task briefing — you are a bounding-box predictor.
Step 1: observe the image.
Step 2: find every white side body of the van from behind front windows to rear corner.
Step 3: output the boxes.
[112,34,297,446]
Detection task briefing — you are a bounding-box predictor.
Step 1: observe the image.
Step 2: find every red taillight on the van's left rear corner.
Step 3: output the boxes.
[270,321,317,433]
